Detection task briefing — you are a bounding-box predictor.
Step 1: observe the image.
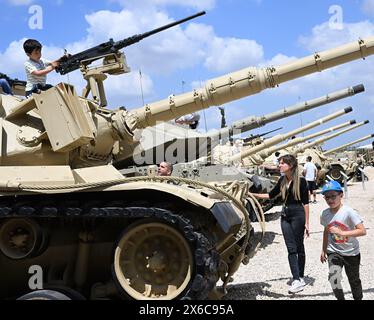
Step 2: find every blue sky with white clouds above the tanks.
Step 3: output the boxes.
[0,0,374,148]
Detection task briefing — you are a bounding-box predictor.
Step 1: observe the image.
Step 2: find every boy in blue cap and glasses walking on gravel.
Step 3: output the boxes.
[321,181,366,300]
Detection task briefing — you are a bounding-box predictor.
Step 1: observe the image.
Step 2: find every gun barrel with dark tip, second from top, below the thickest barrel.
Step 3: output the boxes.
[212,84,365,138]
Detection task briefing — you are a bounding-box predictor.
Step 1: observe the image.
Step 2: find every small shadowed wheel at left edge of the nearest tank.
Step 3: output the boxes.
[0,219,46,260]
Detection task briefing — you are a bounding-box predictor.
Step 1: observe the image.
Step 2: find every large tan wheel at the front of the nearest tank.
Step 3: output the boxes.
[114,222,194,300]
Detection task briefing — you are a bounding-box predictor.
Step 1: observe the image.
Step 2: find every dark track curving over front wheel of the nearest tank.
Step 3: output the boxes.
[0,198,220,300]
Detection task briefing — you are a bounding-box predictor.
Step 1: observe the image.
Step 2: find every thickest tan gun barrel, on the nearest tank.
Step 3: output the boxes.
[127,36,374,130]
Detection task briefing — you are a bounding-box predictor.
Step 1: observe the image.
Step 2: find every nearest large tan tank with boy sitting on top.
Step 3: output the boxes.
[0,21,374,300]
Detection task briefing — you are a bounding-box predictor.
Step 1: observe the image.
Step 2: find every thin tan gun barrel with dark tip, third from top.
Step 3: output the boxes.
[226,107,352,162]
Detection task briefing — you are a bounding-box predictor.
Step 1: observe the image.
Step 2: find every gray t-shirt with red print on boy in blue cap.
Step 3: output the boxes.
[321,205,363,256]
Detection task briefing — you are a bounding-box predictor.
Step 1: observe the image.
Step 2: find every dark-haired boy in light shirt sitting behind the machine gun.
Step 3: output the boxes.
[23,39,59,98]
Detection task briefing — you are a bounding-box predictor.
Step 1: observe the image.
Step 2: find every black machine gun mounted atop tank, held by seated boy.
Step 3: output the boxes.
[56,11,205,75]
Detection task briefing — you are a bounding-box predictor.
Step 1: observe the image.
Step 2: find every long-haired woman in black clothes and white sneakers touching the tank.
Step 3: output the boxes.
[253,155,309,294]
